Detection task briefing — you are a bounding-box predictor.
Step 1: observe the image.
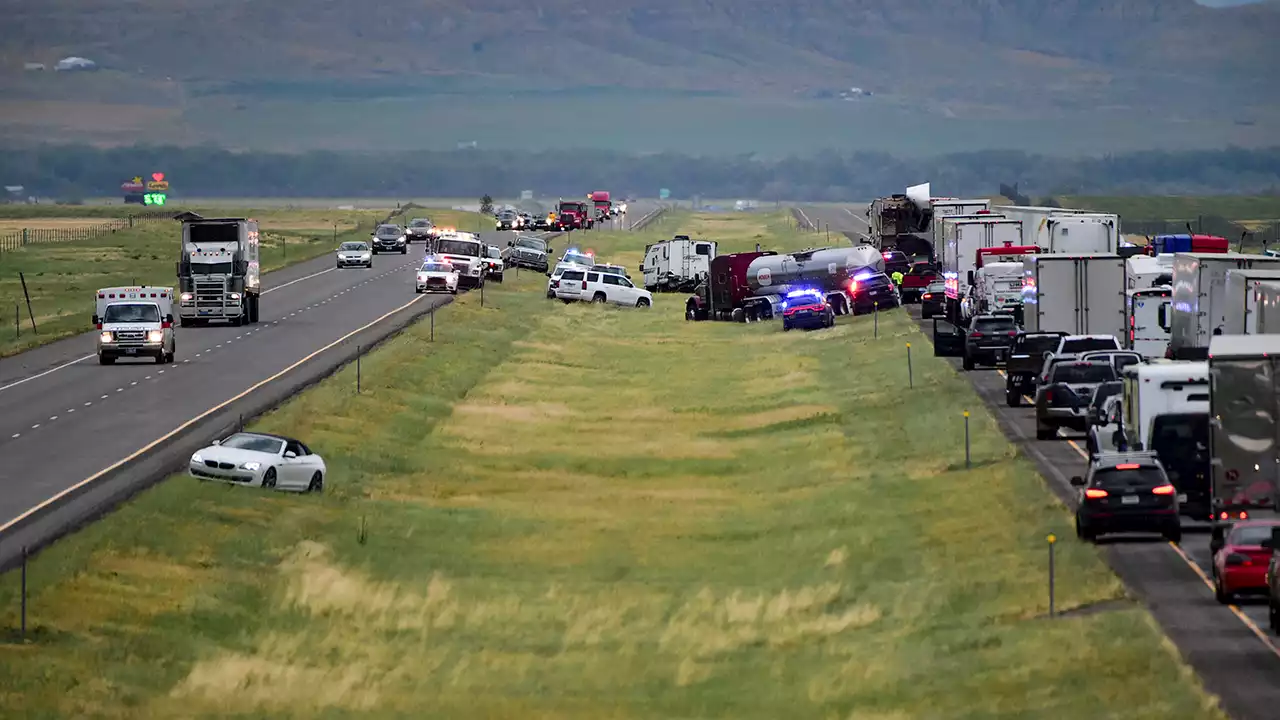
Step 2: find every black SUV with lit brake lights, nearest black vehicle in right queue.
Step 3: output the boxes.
[1071,452,1183,542]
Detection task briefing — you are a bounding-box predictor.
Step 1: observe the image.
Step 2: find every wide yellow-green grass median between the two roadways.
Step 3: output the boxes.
[0,217,1220,719]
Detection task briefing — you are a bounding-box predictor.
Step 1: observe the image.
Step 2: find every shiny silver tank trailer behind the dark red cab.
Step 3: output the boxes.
[746,245,884,295]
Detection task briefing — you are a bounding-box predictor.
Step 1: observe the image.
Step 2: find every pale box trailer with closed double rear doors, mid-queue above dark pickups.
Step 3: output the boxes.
[1023,252,1126,342]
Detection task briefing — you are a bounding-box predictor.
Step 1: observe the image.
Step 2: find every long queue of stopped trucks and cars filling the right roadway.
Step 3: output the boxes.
[870,184,1280,634]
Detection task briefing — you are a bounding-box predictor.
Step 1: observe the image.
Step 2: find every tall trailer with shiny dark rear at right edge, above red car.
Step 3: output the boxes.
[1207,334,1280,552]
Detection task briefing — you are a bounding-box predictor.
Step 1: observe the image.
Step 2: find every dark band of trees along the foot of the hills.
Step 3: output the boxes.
[0,145,1280,201]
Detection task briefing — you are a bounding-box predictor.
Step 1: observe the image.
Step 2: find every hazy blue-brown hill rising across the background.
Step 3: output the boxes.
[0,0,1280,152]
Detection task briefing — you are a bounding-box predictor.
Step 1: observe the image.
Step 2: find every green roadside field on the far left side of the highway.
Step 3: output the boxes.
[0,205,479,356]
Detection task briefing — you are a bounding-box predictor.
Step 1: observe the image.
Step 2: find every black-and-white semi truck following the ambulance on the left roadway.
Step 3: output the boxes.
[177,217,262,327]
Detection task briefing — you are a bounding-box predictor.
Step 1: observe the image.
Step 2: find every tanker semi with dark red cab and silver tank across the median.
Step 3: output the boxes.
[685,245,884,322]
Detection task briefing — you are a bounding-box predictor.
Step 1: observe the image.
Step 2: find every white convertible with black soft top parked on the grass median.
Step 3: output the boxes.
[188,433,326,492]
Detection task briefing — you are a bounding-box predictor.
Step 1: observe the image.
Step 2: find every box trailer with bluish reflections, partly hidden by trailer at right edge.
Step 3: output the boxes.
[1169,252,1280,360]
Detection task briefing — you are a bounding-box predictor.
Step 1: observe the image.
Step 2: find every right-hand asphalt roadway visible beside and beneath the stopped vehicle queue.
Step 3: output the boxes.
[908,305,1280,720]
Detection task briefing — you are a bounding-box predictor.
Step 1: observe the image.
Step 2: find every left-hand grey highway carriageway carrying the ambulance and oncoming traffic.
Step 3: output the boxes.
[0,202,657,564]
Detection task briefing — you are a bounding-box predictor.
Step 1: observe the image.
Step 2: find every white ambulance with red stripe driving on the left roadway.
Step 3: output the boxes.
[93,286,177,365]
